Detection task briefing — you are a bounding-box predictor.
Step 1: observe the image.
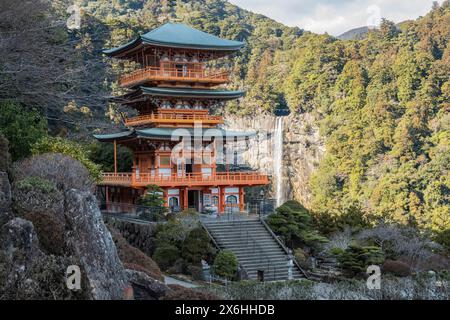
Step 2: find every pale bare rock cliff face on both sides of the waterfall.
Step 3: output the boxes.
[224,113,325,207]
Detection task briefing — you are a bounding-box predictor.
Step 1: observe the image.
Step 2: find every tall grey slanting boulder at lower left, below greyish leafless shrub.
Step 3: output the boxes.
[64,189,128,300]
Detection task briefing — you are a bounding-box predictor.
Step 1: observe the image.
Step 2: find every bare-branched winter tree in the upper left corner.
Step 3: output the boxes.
[0,0,114,136]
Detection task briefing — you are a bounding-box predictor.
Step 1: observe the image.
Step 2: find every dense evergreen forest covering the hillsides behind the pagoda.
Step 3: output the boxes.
[0,0,450,232]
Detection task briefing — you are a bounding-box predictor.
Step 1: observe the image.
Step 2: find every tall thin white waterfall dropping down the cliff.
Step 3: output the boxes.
[273,117,284,207]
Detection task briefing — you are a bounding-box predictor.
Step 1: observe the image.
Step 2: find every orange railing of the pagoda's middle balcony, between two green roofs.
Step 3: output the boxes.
[125,113,223,126]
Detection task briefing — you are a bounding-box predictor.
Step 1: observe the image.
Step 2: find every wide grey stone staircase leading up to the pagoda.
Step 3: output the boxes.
[203,218,305,281]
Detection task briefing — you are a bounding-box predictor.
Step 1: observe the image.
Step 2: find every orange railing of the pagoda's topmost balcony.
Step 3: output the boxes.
[119,67,229,87]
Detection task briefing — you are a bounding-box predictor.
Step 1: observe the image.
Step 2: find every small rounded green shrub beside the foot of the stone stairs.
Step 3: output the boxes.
[182,228,214,264]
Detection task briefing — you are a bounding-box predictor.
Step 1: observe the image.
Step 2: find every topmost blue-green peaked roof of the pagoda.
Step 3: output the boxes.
[103,22,244,56]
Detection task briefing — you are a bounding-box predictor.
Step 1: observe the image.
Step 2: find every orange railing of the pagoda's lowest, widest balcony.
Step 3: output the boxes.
[100,172,269,187]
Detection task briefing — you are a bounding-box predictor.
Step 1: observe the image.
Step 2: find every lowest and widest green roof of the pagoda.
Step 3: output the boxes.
[94,128,256,142]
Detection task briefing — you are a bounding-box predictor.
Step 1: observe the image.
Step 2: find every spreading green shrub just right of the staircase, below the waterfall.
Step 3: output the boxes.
[267,200,328,249]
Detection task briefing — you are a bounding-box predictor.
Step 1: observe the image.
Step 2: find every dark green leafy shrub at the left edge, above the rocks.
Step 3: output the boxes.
[0,102,47,161]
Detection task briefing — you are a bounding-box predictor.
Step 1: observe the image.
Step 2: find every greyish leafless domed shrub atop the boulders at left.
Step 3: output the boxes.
[13,153,94,191]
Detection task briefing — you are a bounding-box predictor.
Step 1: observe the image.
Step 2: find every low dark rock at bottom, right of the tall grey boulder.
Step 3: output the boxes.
[126,269,170,300]
